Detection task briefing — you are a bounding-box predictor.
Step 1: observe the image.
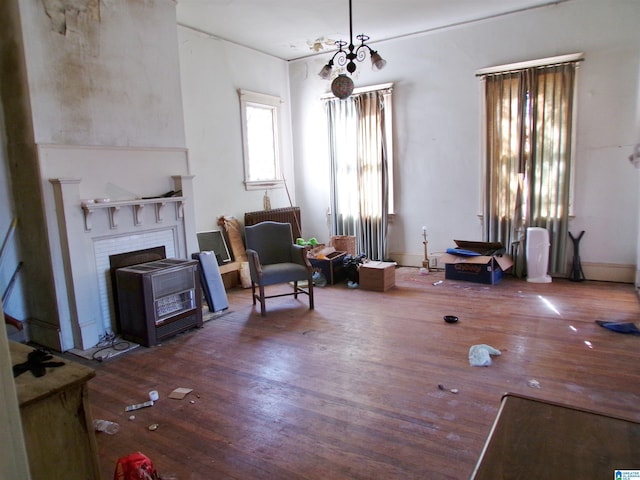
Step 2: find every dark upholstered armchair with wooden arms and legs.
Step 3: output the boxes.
[244,221,313,317]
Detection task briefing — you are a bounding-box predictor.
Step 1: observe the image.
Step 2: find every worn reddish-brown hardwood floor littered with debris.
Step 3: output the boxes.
[90,268,640,480]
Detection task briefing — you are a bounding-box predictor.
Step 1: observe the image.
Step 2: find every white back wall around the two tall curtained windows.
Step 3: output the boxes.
[290,0,640,281]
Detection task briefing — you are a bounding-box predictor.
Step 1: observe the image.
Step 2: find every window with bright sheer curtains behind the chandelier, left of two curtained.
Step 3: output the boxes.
[326,87,393,260]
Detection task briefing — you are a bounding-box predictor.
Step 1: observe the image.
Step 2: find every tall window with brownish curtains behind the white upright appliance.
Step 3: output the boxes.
[483,55,577,274]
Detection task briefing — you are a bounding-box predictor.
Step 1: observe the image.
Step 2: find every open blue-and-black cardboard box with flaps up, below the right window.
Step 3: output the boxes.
[442,240,513,285]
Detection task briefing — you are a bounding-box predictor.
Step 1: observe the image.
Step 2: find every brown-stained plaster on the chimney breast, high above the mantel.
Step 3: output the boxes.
[20,0,185,147]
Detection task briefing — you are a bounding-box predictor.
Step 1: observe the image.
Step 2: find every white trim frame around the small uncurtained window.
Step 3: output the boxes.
[238,89,284,190]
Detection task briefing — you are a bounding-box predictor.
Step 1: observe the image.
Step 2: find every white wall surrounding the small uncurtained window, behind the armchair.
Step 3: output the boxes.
[178,27,298,231]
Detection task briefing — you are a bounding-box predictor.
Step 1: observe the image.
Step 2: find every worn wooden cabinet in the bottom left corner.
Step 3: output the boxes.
[10,342,100,480]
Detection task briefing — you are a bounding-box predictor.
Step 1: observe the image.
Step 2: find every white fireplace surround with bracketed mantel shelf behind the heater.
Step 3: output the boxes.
[45,176,197,351]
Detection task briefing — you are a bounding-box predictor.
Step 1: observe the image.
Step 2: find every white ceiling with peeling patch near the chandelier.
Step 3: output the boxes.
[177,0,566,60]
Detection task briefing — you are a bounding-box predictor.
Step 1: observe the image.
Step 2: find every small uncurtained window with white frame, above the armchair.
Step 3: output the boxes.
[238,90,282,190]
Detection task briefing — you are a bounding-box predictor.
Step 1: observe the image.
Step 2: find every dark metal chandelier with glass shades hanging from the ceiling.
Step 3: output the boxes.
[319,0,387,99]
